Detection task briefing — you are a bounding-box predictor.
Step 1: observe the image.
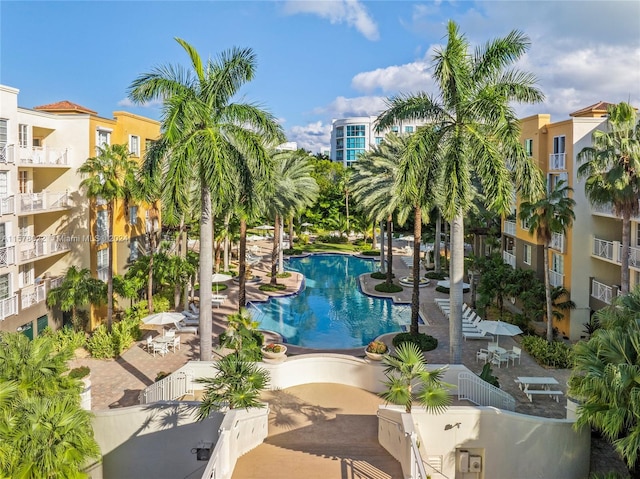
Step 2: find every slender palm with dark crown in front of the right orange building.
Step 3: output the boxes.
[520,180,576,342]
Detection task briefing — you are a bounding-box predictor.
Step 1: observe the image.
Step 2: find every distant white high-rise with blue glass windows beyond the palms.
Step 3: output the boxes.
[330,116,424,167]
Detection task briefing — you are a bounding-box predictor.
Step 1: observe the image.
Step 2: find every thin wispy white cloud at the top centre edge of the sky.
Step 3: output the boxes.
[284,0,380,40]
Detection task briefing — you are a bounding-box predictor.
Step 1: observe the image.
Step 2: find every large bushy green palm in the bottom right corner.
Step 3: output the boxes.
[569,288,640,478]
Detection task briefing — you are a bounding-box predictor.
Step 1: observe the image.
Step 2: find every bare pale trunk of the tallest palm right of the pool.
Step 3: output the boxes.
[449,212,464,364]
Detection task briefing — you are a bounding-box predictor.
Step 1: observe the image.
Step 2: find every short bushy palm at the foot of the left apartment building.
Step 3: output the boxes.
[47,266,107,331]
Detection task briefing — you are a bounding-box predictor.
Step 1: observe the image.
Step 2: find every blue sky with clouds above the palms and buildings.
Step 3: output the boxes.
[0,0,640,152]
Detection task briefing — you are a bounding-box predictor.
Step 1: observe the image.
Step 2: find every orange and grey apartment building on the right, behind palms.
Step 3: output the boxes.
[502,102,616,340]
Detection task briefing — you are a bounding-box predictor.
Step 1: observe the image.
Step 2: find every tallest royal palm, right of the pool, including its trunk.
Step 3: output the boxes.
[378,22,543,364]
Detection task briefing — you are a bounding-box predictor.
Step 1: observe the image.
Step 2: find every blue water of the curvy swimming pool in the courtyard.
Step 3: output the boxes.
[253,254,411,349]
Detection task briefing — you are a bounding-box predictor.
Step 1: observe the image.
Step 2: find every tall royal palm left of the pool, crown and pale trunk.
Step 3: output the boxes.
[129,38,284,361]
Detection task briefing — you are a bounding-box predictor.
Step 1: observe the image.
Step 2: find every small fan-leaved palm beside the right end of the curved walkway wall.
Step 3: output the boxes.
[380,342,451,414]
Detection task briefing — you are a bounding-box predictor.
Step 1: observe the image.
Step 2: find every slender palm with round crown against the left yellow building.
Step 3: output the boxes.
[78,145,137,330]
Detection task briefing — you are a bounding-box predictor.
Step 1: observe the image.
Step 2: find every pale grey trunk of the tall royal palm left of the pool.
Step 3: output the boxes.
[199,184,213,361]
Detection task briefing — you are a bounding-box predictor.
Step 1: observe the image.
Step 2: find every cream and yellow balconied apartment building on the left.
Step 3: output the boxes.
[0,85,160,337]
